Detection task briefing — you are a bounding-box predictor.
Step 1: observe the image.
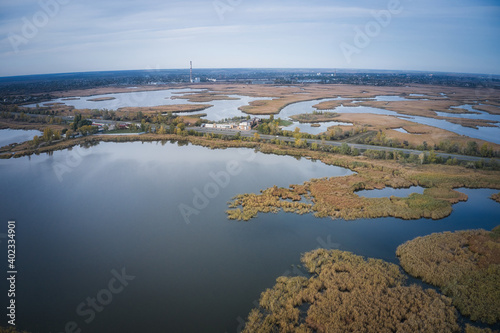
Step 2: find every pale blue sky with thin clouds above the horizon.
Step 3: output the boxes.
[0,0,500,76]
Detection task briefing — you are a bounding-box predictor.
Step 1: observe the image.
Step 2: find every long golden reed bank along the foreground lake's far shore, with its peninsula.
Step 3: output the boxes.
[0,133,500,221]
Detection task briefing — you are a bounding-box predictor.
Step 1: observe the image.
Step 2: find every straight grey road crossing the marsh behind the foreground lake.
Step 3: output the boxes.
[187,127,500,163]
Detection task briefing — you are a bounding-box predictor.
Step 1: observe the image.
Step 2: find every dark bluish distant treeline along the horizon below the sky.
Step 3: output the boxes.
[0,68,500,96]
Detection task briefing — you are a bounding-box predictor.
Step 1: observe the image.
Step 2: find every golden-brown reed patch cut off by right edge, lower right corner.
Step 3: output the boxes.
[396,226,500,324]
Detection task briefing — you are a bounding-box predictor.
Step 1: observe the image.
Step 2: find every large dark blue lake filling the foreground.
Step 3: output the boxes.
[0,142,500,333]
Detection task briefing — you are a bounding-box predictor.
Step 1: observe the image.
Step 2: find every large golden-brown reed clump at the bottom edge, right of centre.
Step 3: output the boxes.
[243,249,459,333]
